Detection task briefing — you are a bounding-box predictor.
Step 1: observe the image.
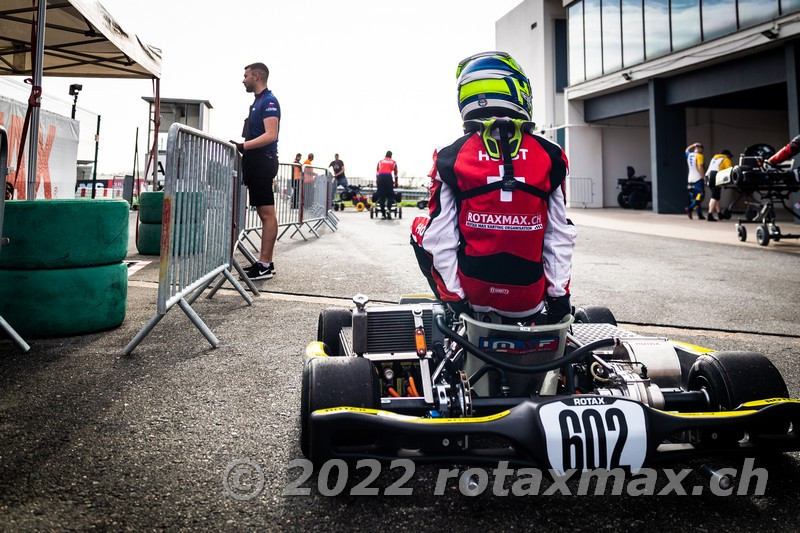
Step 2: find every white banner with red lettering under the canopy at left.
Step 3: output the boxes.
[0,96,80,200]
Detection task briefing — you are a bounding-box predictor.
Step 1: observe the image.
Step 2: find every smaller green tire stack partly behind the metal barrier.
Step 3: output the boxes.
[136,191,205,255]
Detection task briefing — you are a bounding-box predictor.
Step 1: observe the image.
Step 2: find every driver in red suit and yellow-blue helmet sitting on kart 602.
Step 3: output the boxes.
[411,52,576,324]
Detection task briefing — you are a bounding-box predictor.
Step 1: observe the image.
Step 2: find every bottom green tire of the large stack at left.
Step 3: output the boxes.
[0,262,128,338]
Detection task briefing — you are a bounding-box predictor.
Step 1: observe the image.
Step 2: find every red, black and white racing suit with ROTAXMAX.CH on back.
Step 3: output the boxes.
[412,120,576,321]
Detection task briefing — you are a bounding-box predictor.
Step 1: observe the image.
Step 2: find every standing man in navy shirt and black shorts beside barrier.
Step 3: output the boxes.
[239,63,281,280]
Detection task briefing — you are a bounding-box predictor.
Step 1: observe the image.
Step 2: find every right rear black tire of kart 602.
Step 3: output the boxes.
[687,352,789,439]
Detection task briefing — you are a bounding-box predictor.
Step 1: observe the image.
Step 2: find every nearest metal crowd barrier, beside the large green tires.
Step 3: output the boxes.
[124,123,253,355]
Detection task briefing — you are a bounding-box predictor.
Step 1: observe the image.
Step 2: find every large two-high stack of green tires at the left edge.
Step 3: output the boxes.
[0,199,130,338]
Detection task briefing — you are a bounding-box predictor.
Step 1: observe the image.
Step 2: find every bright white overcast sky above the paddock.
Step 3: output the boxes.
[0,0,531,181]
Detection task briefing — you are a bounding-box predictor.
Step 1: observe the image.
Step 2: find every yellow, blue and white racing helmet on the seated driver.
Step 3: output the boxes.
[456,52,533,120]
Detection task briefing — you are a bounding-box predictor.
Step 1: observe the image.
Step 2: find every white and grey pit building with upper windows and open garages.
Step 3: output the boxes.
[496,0,800,213]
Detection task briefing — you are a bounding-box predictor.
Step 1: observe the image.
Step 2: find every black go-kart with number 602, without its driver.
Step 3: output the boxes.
[301,295,800,473]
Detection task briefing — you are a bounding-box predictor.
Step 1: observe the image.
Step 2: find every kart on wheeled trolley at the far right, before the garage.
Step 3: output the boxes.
[716,144,800,246]
